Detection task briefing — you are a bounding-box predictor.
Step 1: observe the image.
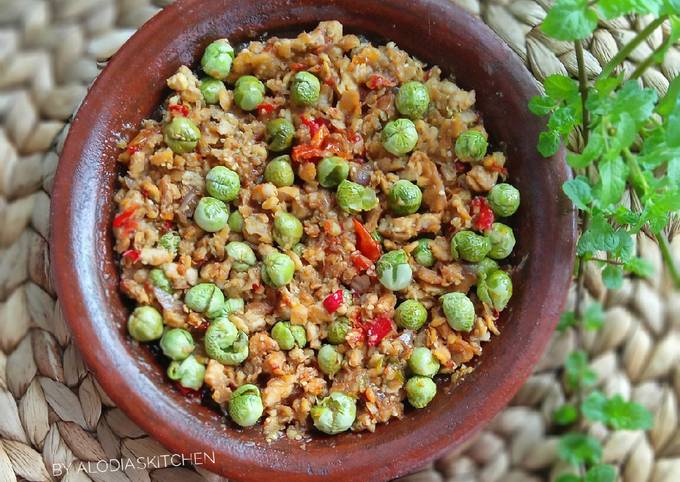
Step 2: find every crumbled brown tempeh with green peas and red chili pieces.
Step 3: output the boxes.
[113,21,520,440]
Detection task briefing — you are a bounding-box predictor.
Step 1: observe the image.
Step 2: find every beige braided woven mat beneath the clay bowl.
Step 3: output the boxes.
[0,0,680,482]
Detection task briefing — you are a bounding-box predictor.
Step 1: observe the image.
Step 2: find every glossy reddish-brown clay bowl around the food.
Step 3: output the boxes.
[51,0,575,481]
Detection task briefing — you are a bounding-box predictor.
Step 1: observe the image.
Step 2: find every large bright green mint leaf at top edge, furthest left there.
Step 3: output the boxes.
[541,0,597,40]
